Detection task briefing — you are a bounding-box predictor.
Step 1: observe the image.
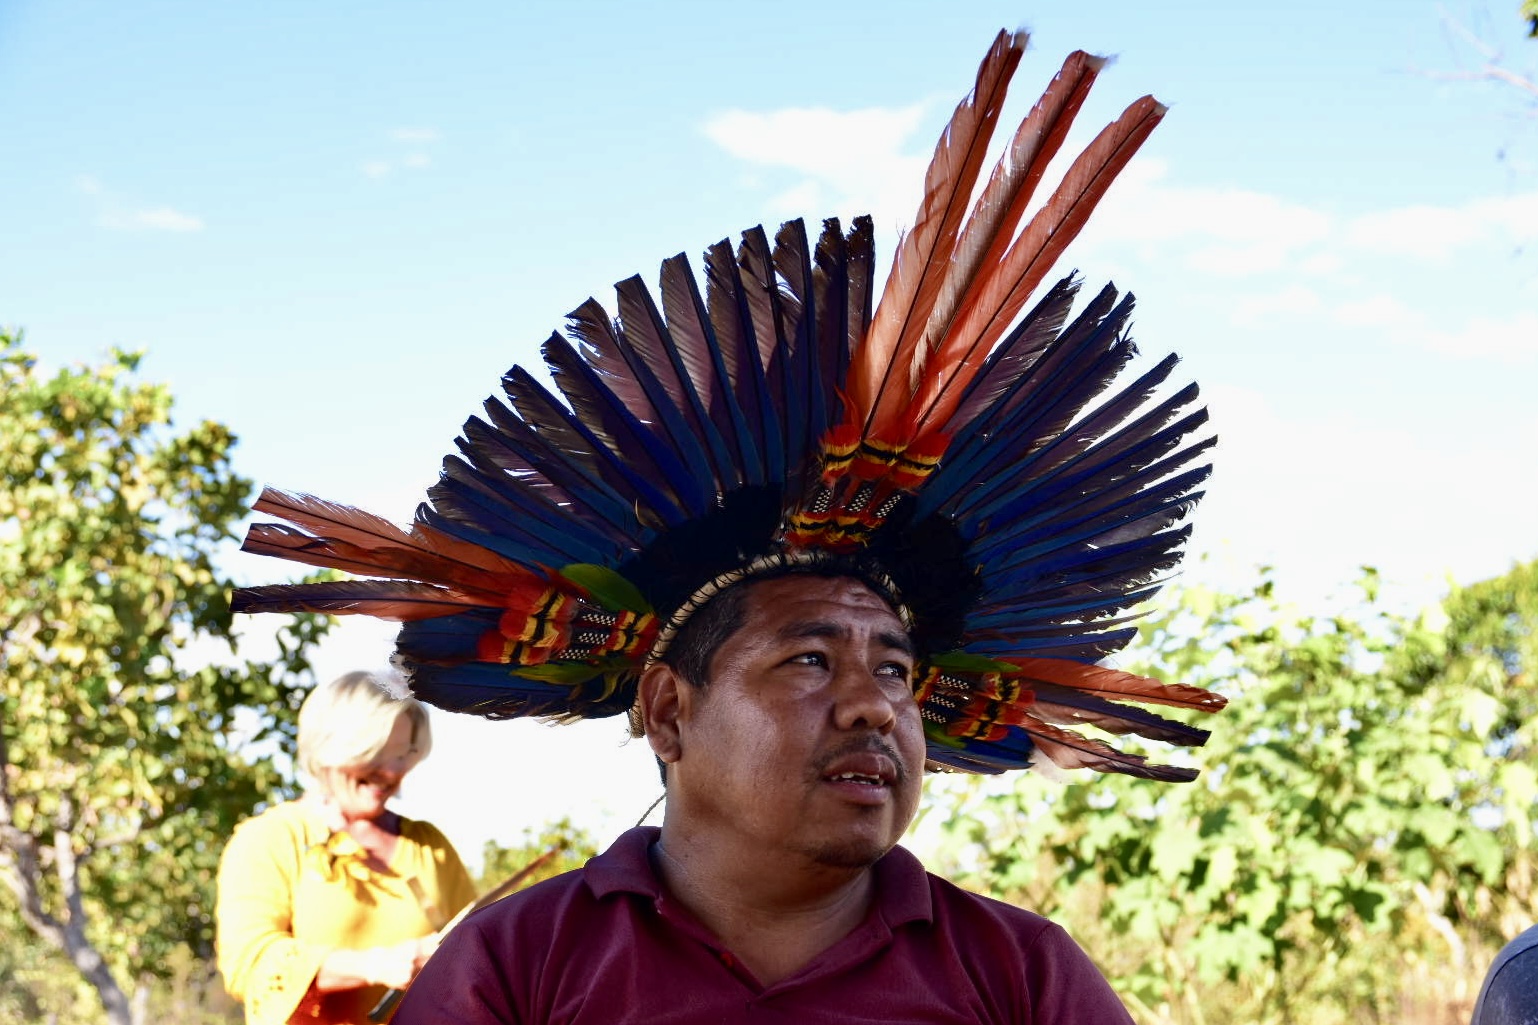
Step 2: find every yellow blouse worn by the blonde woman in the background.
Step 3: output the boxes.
[215,800,475,1025]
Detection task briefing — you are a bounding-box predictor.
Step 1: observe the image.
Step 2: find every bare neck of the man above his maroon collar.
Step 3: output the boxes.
[652,826,875,987]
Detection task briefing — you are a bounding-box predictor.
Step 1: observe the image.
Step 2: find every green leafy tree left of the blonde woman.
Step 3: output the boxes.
[0,332,326,1025]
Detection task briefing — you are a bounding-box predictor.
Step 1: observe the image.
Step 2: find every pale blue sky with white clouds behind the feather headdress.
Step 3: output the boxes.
[0,0,1538,851]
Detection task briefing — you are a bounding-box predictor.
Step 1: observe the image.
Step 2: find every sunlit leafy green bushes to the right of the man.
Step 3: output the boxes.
[922,563,1538,1023]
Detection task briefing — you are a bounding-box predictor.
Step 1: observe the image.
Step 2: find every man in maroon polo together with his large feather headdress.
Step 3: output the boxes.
[234,25,1224,1025]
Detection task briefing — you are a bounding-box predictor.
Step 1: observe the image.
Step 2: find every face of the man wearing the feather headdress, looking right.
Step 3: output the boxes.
[669,576,924,868]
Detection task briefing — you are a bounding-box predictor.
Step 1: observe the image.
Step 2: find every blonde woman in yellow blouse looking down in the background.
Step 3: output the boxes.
[215,673,475,1025]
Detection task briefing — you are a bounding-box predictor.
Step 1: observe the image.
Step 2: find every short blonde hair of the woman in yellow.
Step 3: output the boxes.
[298,671,432,782]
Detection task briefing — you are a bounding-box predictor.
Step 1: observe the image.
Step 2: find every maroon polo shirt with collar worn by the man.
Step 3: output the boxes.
[394,828,1132,1025]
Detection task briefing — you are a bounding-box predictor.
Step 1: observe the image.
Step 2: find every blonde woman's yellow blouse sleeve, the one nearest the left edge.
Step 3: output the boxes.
[214,820,328,1025]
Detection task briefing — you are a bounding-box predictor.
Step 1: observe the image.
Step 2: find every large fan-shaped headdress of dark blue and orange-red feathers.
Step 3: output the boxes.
[234,32,1223,780]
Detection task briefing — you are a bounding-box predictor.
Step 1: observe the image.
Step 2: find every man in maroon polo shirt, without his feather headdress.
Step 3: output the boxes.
[395,563,1132,1025]
